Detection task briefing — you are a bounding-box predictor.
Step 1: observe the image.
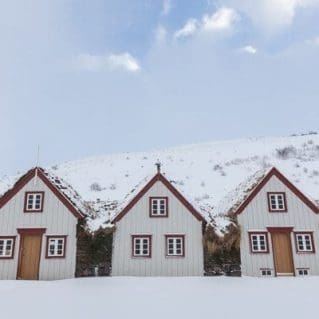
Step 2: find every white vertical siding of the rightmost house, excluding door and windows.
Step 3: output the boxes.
[238,176,319,276]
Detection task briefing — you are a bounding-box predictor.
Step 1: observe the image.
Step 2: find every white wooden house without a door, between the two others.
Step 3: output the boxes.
[112,166,204,276]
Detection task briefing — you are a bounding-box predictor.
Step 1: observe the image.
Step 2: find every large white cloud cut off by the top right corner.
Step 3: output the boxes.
[228,0,319,32]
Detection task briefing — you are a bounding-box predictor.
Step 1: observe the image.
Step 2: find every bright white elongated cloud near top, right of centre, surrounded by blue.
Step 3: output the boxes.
[174,7,239,38]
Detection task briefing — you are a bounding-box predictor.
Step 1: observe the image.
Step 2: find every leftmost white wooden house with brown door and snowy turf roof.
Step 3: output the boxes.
[0,168,84,280]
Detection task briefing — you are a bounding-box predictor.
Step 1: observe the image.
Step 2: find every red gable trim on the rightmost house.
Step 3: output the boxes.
[235,167,319,215]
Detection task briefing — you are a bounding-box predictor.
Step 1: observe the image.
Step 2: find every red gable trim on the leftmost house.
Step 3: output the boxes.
[0,167,84,218]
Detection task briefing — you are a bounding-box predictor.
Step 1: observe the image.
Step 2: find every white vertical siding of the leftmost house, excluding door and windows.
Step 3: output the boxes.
[0,178,77,280]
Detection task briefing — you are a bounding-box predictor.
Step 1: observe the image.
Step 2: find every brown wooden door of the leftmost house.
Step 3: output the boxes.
[17,234,42,280]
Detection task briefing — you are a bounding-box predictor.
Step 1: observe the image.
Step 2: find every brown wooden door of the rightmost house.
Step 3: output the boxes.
[271,232,294,276]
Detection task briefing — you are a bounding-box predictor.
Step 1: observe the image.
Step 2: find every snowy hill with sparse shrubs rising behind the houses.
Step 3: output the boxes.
[0,134,319,234]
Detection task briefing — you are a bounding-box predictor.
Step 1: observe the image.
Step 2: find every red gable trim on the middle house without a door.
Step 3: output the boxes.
[112,173,205,223]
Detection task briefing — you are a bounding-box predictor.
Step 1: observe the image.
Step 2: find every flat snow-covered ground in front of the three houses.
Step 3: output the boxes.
[0,277,319,319]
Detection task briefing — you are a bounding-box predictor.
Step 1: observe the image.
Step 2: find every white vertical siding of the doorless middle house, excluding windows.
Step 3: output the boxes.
[112,181,204,276]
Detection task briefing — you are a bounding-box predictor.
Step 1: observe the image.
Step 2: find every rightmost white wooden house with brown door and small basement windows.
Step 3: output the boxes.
[233,168,319,276]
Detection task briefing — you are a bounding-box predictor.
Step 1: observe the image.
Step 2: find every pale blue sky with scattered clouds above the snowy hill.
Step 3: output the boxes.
[0,0,319,175]
